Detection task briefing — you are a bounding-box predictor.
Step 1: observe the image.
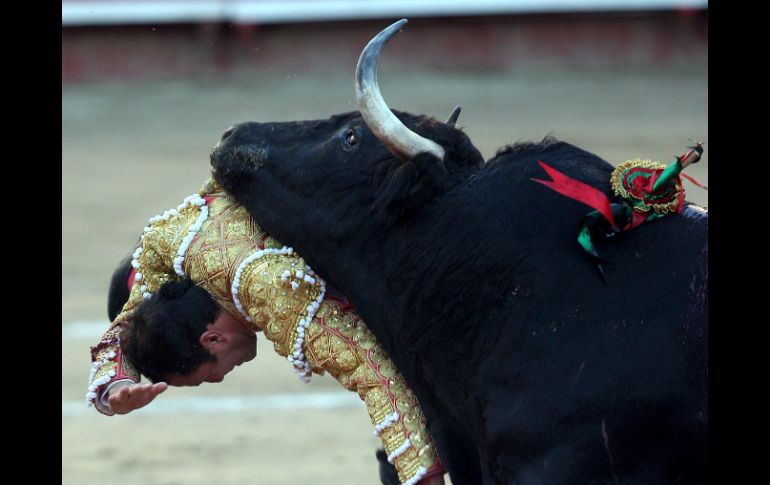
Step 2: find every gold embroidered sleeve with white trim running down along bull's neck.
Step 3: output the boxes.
[233,248,444,485]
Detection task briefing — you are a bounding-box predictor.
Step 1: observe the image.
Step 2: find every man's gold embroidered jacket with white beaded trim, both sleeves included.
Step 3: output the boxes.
[87,180,442,484]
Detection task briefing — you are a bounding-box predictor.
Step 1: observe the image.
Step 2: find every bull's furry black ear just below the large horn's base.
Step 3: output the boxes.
[371,153,451,226]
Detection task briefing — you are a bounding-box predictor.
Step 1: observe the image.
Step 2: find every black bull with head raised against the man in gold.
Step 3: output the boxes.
[211,113,708,484]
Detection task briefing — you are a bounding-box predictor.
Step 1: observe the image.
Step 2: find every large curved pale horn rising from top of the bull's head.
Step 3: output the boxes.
[356,19,444,160]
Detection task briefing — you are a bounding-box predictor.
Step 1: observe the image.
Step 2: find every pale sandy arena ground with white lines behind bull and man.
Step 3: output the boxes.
[62,62,708,485]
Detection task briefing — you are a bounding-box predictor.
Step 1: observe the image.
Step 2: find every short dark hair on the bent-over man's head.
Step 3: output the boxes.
[120,278,220,382]
